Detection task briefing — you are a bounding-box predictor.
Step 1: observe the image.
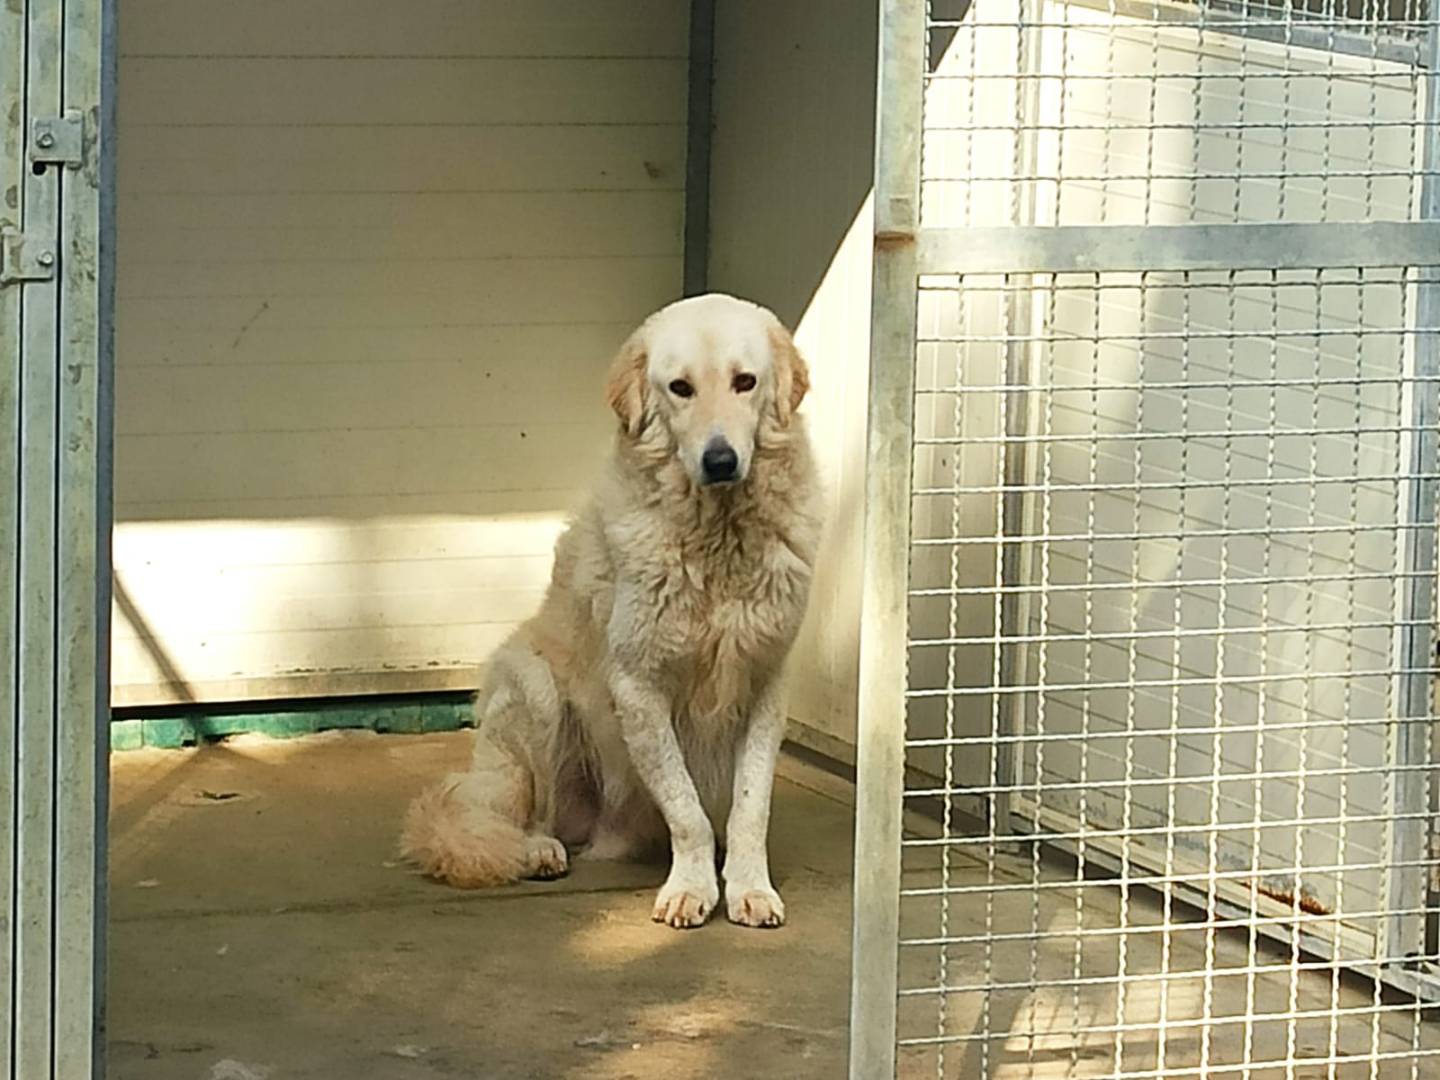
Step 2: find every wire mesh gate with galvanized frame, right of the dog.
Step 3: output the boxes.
[851,0,1440,1080]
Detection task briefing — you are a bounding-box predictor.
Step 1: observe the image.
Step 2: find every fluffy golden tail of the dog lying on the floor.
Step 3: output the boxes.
[400,773,528,888]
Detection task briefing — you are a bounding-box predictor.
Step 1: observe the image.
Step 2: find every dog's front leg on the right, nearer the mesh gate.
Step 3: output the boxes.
[724,678,785,926]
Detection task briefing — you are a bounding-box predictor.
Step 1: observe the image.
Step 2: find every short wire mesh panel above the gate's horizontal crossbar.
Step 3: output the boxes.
[922,0,1433,226]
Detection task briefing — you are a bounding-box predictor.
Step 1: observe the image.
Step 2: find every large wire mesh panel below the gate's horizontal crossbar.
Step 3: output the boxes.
[900,269,1440,1076]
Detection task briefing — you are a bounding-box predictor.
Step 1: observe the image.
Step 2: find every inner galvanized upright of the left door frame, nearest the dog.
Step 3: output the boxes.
[53,0,115,1080]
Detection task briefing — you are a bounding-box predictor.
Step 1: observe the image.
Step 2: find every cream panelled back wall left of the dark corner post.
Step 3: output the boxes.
[114,0,688,704]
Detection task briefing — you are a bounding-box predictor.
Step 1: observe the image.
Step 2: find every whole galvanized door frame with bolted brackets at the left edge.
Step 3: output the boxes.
[0,0,115,1080]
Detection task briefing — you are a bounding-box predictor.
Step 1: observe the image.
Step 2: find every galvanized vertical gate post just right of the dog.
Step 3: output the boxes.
[850,0,924,1080]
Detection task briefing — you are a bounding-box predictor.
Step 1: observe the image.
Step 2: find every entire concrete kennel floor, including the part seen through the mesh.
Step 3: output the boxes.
[109,733,1440,1080]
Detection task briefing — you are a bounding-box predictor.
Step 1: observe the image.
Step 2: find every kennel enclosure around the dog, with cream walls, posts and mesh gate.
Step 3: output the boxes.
[8,0,1440,1080]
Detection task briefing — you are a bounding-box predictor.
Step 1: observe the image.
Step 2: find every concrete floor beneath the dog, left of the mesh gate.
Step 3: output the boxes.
[109,733,851,1080]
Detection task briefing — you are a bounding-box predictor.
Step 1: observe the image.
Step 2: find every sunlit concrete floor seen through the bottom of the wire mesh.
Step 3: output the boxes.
[899,850,1440,1080]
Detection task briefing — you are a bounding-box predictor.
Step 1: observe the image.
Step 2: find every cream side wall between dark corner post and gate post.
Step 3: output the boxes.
[710,0,878,759]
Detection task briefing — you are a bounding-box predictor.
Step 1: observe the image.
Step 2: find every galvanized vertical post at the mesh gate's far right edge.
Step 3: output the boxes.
[1384,10,1440,963]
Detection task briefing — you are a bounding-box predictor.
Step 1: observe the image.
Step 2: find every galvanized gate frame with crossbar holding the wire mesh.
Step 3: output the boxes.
[850,0,1440,1080]
